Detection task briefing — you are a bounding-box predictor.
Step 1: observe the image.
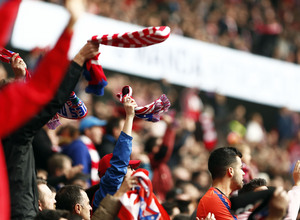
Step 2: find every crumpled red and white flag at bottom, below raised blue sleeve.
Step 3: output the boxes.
[118,169,170,220]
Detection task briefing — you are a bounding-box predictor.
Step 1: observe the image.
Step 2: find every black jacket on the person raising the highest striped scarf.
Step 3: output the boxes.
[3,62,83,219]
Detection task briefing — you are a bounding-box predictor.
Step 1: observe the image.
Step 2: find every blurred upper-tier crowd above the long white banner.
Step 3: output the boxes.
[49,0,300,63]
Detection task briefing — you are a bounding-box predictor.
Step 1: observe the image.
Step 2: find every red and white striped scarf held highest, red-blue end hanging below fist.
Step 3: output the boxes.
[84,26,170,95]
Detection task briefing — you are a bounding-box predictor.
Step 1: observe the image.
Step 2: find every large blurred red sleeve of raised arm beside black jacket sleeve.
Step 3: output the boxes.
[0,29,73,137]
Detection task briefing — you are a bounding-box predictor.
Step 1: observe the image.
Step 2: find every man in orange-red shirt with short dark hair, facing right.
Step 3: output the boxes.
[197,147,245,220]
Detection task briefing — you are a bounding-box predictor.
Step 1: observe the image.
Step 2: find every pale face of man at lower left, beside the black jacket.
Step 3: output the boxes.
[38,184,56,211]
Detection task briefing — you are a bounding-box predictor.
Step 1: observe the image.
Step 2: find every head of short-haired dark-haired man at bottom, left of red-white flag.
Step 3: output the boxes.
[55,185,92,220]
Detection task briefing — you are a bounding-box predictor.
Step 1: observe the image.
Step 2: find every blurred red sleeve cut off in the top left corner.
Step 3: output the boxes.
[0,0,21,46]
